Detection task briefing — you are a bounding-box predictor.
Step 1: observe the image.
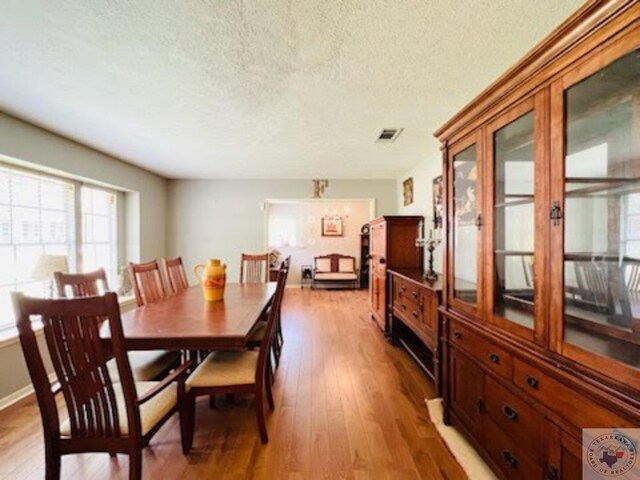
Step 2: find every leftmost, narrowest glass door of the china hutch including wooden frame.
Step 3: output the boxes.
[449,135,481,314]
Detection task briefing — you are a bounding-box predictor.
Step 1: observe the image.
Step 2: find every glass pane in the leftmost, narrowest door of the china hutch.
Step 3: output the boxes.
[453,144,478,304]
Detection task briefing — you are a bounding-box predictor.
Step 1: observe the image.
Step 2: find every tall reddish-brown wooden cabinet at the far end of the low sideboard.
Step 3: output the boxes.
[369,216,424,335]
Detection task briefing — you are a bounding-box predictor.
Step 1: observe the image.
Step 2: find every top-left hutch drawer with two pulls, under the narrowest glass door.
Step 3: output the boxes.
[449,320,513,378]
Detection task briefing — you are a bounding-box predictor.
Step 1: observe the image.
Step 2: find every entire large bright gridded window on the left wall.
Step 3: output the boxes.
[0,163,118,330]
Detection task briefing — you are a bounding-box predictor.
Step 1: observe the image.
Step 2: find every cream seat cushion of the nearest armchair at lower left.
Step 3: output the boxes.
[60,382,178,437]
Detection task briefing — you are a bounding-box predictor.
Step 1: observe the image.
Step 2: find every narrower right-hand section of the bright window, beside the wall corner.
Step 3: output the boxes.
[80,185,118,287]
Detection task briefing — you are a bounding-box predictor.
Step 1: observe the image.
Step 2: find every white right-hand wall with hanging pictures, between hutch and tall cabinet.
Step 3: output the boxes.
[398,151,443,272]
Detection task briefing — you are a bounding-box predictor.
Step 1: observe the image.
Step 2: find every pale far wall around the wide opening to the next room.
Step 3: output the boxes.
[168,180,397,282]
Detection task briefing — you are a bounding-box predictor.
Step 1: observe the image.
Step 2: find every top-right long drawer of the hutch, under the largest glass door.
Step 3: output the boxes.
[513,359,638,429]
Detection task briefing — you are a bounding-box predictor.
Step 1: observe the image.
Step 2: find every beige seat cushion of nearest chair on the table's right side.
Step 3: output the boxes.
[187,350,258,390]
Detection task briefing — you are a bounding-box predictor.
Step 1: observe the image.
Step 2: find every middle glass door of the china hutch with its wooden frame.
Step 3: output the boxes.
[486,98,537,339]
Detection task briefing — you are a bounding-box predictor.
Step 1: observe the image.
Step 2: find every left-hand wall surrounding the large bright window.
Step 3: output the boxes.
[0,113,167,400]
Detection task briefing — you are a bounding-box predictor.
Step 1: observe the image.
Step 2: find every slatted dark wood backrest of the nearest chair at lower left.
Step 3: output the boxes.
[12,292,140,439]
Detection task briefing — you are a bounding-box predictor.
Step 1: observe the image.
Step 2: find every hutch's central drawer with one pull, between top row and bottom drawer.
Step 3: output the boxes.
[484,375,544,462]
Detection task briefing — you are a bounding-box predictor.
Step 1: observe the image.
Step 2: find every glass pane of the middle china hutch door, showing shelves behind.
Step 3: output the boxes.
[493,112,535,328]
